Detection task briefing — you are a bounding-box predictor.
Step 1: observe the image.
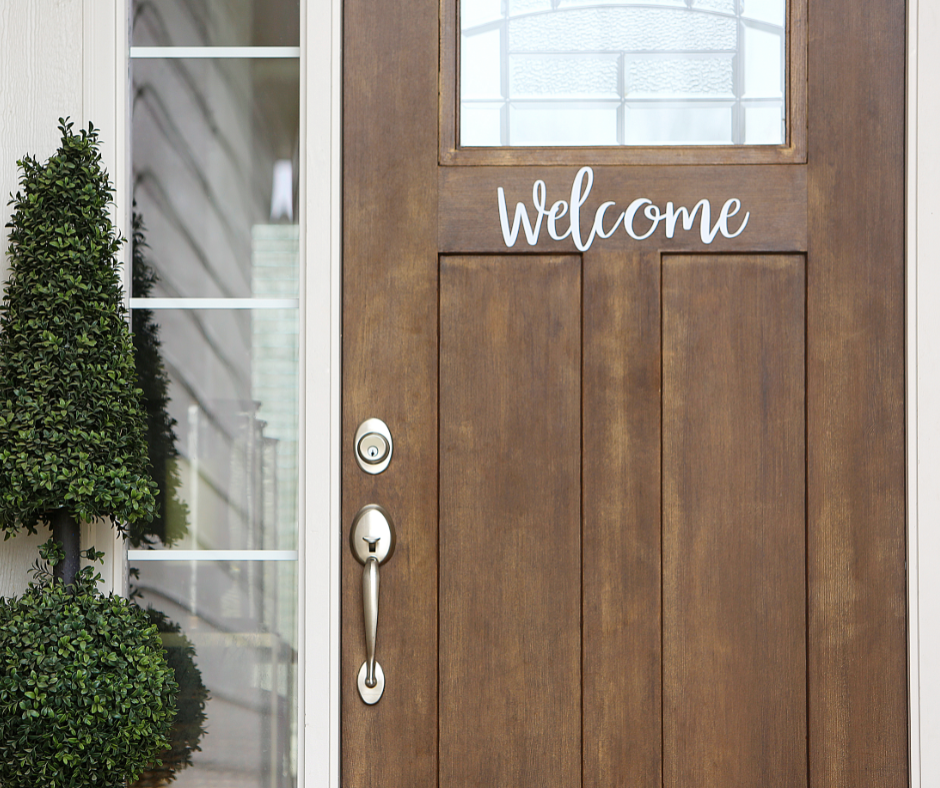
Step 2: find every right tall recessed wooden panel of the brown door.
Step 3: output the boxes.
[662,256,807,788]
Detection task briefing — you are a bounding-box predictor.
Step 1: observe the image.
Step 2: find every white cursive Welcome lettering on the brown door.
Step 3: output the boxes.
[496,167,751,252]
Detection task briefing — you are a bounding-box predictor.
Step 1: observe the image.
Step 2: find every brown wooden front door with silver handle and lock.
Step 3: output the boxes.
[342,0,907,788]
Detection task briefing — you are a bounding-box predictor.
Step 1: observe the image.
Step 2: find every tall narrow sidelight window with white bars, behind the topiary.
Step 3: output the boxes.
[128,0,300,788]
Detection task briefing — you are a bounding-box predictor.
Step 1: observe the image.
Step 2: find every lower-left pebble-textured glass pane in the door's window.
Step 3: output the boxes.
[509,55,620,98]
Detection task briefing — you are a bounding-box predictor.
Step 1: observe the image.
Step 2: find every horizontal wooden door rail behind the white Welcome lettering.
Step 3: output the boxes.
[439,166,806,254]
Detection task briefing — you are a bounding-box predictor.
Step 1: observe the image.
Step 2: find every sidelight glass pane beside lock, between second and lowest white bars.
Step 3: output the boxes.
[126,310,299,552]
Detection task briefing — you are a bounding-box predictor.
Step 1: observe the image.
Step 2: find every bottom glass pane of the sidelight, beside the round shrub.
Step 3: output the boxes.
[137,561,297,788]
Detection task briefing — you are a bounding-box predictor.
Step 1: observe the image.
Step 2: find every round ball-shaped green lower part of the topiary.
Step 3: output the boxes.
[0,541,177,788]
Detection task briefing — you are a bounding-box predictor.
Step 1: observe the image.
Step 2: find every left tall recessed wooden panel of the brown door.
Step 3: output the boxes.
[439,256,581,788]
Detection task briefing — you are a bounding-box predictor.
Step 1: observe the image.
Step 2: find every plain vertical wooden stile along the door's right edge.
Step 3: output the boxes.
[807,0,908,788]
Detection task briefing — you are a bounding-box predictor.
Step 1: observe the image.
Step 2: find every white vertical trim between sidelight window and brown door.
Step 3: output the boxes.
[298,0,343,788]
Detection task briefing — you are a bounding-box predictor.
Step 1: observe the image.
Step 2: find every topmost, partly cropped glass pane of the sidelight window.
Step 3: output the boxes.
[131,0,300,47]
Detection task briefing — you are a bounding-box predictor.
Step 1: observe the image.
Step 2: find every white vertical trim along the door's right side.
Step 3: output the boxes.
[907,0,940,788]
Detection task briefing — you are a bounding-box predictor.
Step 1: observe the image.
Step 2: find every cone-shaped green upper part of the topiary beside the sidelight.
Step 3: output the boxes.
[0,120,156,536]
